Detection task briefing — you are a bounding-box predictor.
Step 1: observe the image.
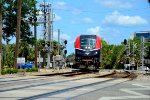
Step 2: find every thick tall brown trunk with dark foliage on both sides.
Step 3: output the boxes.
[14,0,22,68]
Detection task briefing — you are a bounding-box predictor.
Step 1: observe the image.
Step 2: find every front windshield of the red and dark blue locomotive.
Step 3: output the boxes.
[80,37,96,49]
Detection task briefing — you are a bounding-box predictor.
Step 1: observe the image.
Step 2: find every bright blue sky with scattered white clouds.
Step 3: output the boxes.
[9,0,150,54]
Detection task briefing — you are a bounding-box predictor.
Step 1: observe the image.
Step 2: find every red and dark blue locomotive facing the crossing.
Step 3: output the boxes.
[75,35,101,70]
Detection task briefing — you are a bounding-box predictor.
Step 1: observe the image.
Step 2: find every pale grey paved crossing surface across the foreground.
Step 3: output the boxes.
[0,73,150,100]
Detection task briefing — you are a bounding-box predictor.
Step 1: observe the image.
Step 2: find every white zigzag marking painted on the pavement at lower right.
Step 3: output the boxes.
[98,84,150,100]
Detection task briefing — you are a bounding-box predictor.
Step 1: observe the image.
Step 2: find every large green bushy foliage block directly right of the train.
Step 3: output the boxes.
[101,40,124,69]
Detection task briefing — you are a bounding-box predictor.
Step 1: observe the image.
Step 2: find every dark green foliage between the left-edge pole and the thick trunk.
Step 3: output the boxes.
[3,0,17,44]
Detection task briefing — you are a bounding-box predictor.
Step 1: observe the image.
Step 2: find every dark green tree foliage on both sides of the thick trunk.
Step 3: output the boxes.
[3,0,37,45]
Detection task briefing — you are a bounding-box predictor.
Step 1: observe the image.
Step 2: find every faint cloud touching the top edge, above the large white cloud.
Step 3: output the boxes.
[96,0,133,8]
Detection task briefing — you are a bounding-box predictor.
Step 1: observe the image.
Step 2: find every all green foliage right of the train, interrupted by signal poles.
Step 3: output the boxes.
[101,37,150,69]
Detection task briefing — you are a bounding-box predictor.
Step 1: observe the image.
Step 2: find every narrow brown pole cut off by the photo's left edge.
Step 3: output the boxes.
[0,0,3,75]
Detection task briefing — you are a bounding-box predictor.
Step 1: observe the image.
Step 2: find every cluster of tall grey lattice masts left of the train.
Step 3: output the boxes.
[40,0,53,68]
